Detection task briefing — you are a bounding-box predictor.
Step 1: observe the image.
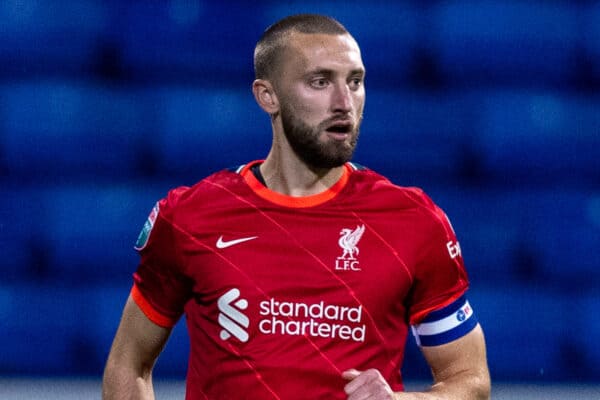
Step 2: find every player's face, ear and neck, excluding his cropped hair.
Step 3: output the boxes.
[252,33,365,196]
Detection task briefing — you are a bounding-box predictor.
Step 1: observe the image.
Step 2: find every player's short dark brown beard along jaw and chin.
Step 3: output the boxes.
[280,105,362,169]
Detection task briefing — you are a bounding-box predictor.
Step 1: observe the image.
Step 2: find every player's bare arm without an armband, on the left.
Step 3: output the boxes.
[102,296,171,400]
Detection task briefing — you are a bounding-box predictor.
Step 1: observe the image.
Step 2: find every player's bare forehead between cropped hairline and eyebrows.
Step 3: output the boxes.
[283,32,364,70]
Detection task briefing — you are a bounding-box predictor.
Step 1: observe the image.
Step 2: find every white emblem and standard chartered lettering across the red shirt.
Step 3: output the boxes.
[218,289,366,342]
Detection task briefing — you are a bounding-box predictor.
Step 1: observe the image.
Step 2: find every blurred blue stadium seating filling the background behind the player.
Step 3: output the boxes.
[0,0,600,399]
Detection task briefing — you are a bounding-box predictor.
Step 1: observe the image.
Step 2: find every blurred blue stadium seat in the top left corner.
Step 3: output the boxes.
[0,0,109,76]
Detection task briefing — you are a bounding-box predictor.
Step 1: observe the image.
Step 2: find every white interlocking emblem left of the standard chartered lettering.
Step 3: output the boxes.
[217,288,250,342]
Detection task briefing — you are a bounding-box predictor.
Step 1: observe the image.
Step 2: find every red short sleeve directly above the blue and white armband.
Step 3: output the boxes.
[408,194,469,325]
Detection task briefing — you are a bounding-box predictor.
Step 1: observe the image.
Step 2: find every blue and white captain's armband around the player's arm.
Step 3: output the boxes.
[411,296,477,346]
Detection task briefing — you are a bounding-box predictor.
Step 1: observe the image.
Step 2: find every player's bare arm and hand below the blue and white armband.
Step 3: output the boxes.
[343,325,491,400]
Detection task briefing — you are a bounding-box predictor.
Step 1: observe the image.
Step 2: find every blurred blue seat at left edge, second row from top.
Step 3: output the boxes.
[0,81,153,179]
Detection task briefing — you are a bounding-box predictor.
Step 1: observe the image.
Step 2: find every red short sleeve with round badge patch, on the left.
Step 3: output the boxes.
[131,188,191,328]
